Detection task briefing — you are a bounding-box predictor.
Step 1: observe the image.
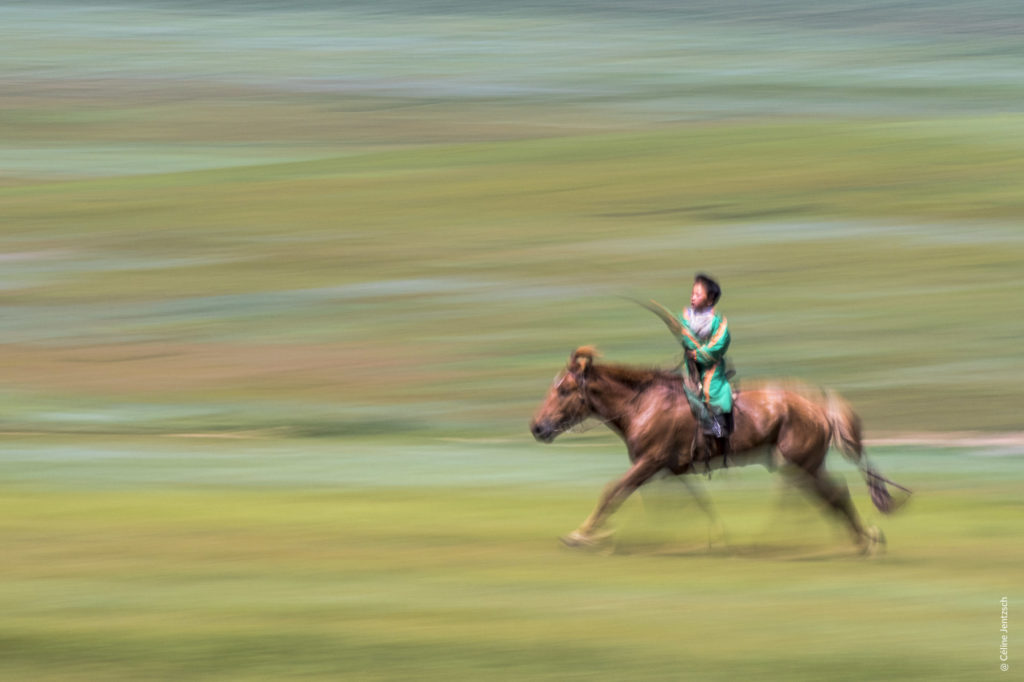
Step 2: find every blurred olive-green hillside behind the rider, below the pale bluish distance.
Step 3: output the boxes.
[0,119,1024,434]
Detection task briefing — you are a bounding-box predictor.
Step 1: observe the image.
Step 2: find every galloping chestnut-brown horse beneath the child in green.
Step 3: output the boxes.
[530,346,908,552]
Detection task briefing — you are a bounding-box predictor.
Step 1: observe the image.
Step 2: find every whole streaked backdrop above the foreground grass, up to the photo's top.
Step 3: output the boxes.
[6,1,1024,435]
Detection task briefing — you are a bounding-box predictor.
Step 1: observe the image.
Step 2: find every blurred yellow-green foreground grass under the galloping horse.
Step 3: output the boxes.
[0,436,1024,680]
